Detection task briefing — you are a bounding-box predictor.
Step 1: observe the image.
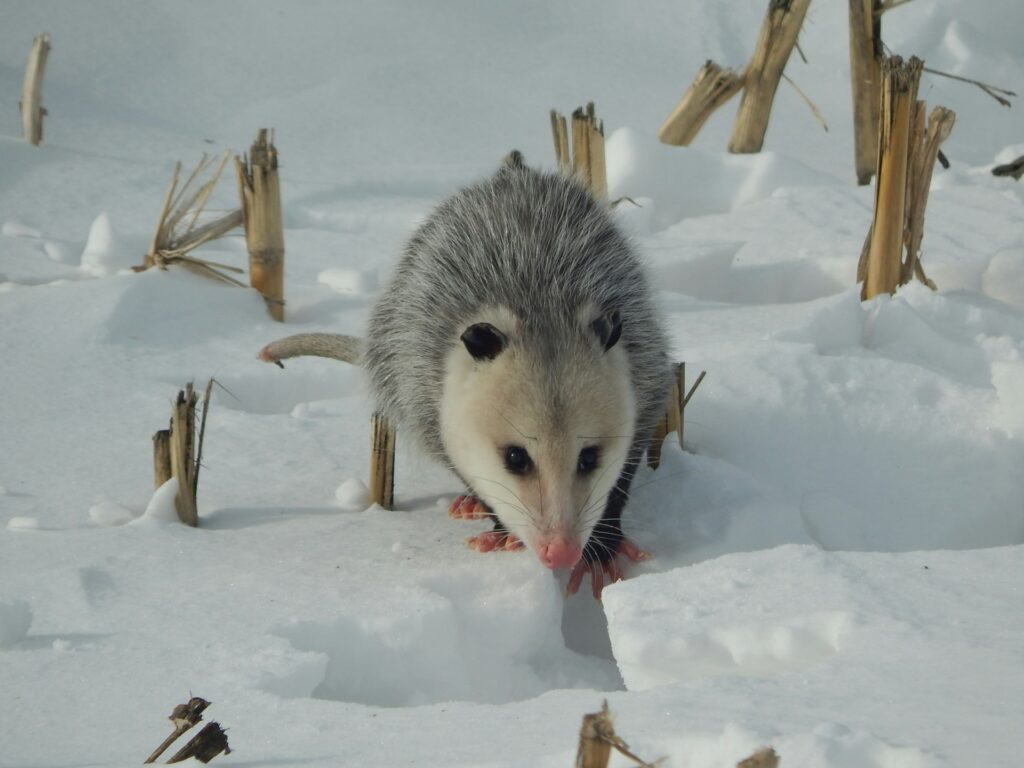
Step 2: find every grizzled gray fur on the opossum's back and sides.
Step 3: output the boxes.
[362,158,670,468]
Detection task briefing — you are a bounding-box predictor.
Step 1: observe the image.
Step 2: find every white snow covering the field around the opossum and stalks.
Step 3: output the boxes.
[0,0,1024,768]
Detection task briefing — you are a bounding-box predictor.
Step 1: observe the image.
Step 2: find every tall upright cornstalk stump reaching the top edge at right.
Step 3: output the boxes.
[849,0,883,185]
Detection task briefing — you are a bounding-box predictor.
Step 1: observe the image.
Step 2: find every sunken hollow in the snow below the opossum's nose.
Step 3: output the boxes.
[261,563,622,707]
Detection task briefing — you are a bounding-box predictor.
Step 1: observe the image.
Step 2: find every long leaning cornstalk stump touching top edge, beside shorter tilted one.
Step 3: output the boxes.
[729,0,811,154]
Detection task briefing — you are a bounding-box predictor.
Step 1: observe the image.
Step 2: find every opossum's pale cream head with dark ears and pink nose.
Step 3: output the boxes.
[440,307,637,568]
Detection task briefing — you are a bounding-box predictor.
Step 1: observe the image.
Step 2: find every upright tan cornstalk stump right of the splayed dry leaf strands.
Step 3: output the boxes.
[236,128,285,323]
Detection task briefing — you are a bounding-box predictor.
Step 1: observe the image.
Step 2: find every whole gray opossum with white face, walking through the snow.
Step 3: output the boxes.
[260,153,671,596]
